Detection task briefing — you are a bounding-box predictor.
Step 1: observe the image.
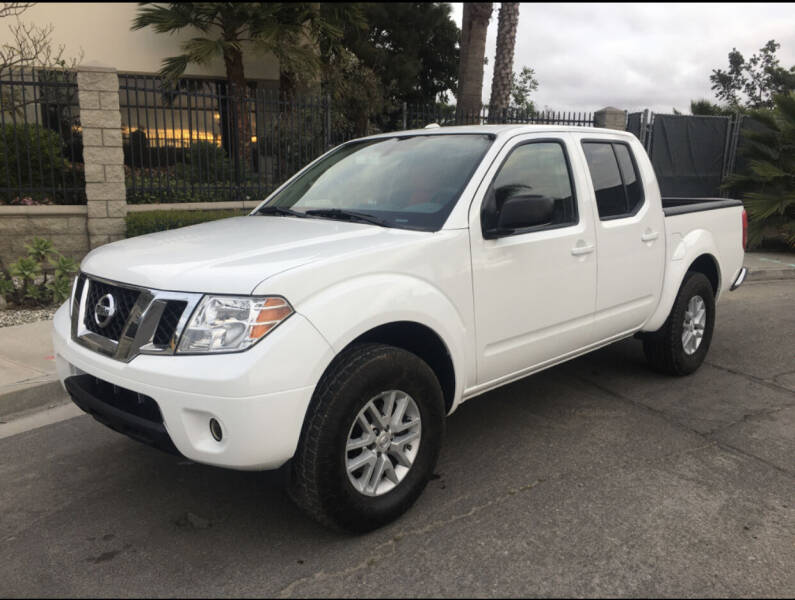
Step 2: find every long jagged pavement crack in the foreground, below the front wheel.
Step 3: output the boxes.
[274,479,545,598]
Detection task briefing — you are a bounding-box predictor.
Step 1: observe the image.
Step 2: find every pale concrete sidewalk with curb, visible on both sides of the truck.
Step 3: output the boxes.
[0,252,795,421]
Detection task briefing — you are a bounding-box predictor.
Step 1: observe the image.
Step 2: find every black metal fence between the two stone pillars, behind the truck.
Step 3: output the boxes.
[119,75,593,204]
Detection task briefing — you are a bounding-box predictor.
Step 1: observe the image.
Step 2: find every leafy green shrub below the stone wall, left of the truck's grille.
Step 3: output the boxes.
[0,237,78,306]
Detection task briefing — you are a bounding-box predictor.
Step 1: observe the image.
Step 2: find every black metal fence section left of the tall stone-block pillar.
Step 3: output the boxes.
[0,69,86,205]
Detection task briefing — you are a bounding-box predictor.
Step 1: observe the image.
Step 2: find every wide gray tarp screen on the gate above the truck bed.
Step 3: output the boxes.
[650,115,729,198]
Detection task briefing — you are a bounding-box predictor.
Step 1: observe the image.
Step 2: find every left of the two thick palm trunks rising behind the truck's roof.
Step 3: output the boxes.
[456,2,492,123]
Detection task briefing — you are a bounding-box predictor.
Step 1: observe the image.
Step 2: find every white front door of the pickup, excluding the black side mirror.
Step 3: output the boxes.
[469,134,596,385]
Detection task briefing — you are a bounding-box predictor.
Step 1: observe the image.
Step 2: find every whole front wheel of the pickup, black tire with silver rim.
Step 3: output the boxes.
[288,344,444,532]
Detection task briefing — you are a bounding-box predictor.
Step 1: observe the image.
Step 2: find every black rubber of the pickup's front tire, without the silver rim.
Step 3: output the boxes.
[287,344,445,533]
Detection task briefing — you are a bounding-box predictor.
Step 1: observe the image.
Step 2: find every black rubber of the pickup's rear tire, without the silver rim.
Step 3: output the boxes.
[643,271,715,375]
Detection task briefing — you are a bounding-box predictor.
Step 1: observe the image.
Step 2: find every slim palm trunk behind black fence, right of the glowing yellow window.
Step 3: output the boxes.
[224,50,252,181]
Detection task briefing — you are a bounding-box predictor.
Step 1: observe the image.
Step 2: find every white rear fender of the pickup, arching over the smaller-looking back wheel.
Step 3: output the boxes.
[641,229,721,331]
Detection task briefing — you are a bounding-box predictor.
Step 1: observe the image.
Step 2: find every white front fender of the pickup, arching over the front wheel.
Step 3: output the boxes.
[295,273,474,407]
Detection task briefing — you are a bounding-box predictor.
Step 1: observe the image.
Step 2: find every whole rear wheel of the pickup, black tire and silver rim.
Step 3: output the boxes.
[643,271,715,375]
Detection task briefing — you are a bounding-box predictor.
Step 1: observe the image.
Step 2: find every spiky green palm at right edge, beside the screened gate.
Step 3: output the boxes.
[724,92,795,248]
